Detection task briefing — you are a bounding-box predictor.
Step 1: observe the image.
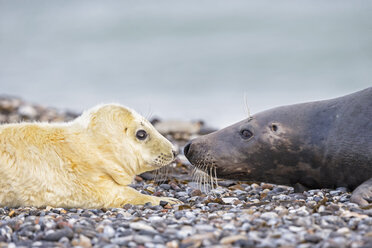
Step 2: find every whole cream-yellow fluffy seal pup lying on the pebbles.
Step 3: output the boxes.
[0,104,178,208]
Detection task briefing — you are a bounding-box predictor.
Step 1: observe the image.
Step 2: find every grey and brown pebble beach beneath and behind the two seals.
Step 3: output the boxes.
[0,96,372,248]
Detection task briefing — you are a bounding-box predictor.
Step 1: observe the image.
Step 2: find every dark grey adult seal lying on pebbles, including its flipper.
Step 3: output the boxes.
[184,88,372,205]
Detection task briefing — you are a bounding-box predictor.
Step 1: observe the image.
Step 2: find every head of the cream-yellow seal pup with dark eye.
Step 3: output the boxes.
[74,104,176,174]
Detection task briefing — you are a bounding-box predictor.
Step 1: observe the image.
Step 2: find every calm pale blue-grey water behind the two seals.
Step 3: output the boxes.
[0,0,372,127]
